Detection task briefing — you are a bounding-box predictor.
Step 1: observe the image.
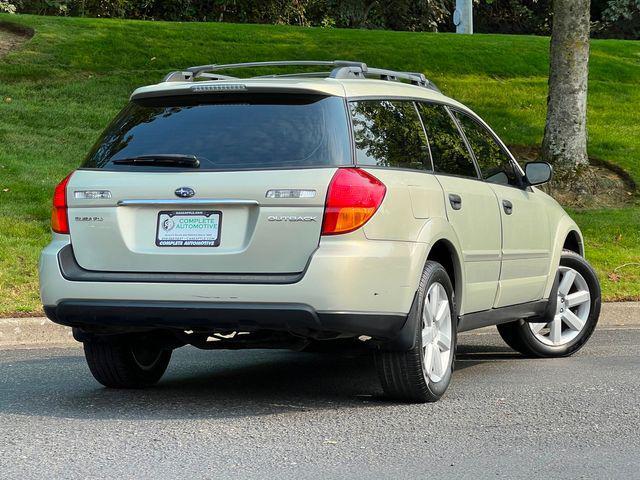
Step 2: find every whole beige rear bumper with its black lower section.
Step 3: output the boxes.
[40,231,428,338]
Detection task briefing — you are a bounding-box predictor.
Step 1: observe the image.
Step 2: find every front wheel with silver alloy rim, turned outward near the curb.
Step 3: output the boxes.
[498,251,601,357]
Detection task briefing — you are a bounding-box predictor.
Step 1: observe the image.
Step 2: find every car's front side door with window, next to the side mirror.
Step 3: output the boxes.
[455,112,551,307]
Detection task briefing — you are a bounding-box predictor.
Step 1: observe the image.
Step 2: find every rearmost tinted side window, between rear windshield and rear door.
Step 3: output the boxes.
[350,100,431,170]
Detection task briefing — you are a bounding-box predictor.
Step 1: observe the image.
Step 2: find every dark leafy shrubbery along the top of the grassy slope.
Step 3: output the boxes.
[8,0,640,38]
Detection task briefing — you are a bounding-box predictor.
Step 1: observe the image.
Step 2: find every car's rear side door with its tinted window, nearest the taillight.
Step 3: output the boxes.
[418,103,502,313]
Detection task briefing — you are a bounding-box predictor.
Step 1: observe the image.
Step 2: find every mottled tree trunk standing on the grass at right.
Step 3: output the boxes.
[542,0,590,172]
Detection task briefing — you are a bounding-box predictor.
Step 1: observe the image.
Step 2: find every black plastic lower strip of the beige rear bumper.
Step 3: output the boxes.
[45,300,407,339]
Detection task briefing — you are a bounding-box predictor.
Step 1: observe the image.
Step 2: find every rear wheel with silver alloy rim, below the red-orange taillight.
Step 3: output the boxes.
[376,261,457,403]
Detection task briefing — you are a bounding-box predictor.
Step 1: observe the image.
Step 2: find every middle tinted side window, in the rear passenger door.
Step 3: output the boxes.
[418,103,478,178]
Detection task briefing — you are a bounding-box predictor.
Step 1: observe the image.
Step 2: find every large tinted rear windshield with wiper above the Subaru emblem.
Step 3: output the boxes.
[82,94,352,171]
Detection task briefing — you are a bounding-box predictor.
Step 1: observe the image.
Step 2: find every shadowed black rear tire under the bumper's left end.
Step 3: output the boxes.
[84,338,171,388]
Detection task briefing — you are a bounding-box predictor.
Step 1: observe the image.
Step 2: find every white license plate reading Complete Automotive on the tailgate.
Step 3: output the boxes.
[156,210,222,247]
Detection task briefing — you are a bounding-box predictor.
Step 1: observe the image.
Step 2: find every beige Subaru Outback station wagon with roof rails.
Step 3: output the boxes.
[40,61,600,402]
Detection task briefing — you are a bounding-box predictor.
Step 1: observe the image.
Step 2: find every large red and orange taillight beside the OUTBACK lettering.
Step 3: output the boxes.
[322,168,387,235]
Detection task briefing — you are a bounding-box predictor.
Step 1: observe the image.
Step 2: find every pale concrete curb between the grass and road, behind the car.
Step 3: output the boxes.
[0,302,640,348]
